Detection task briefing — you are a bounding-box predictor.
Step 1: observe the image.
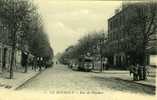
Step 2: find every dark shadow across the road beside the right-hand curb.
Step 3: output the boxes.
[91,76,155,95]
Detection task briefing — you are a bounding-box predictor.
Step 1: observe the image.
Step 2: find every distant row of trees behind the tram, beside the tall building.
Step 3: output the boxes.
[59,31,105,63]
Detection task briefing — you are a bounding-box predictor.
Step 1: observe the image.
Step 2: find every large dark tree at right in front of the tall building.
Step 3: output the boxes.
[125,2,157,79]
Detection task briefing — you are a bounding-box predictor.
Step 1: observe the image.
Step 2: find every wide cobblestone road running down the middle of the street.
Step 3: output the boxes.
[19,65,155,95]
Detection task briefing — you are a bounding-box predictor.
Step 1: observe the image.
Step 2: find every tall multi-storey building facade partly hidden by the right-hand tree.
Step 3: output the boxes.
[105,4,157,67]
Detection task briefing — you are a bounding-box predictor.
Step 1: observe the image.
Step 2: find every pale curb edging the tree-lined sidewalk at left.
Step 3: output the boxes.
[12,69,46,90]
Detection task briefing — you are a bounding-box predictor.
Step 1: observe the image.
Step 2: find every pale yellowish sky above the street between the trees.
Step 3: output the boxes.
[34,0,121,54]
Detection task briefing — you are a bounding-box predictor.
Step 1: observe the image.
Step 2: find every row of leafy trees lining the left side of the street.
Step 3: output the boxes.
[0,0,53,78]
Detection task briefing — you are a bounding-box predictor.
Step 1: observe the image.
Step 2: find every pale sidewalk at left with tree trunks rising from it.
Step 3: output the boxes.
[0,68,40,90]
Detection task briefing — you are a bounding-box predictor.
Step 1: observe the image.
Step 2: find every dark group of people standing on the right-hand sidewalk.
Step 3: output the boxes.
[129,64,146,81]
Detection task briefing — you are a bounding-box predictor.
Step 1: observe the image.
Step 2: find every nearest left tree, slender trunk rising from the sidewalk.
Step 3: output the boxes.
[0,0,37,79]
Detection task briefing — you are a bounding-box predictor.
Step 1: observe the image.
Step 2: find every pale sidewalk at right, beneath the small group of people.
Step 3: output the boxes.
[102,71,156,87]
